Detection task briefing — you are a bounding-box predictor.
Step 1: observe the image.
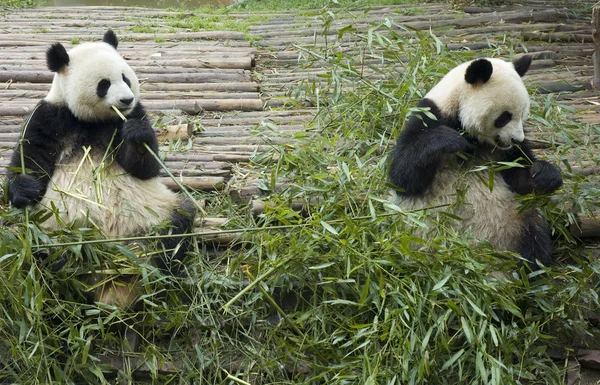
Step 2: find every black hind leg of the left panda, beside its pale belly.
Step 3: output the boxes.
[155,198,196,276]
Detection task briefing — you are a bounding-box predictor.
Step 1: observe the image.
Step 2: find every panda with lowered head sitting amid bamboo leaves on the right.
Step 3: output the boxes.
[389,55,562,270]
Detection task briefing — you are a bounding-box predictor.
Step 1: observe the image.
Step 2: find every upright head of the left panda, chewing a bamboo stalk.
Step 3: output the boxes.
[45,29,140,122]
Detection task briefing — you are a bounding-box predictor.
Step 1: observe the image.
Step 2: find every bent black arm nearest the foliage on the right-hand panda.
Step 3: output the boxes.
[389,99,469,195]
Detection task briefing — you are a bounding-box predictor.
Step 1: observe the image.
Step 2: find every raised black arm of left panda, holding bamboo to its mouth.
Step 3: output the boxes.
[117,103,160,179]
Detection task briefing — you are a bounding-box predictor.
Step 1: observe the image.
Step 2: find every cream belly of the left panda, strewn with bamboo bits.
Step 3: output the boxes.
[40,148,179,236]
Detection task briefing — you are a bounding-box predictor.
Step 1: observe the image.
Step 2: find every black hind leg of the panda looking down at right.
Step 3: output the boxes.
[520,211,553,271]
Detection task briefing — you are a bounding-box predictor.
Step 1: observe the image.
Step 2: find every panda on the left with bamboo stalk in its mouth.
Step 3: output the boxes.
[8,29,195,302]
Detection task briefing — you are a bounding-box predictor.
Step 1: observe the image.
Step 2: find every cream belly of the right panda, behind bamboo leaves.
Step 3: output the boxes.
[397,165,523,252]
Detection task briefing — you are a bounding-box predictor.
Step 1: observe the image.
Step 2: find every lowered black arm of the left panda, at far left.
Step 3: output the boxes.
[8,101,62,208]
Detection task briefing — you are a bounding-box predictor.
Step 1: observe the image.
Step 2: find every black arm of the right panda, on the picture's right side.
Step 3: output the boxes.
[502,140,563,195]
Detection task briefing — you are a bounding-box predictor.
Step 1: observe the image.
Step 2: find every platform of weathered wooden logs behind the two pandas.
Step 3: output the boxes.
[0,0,600,378]
